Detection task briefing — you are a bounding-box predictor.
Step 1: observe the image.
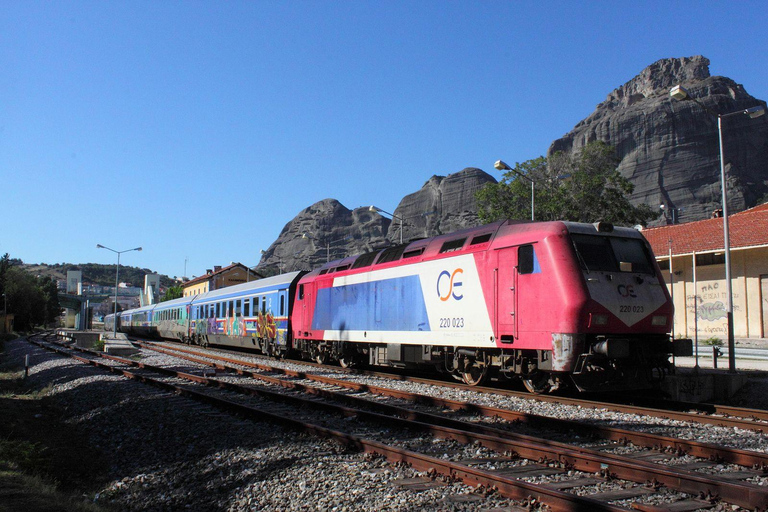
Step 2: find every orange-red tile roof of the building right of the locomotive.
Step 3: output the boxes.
[642,203,768,256]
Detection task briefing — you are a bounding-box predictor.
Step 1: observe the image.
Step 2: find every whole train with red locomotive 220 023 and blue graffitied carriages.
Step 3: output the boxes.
[105,220,691,393]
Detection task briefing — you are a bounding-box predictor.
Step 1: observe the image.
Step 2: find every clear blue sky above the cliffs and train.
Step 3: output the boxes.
[0,0,768,276]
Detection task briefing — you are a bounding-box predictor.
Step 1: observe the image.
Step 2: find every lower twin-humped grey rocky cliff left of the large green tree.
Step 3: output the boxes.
[258,168,496,274]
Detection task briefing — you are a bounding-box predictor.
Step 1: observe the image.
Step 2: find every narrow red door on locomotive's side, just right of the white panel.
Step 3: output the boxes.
[495,247,517,343]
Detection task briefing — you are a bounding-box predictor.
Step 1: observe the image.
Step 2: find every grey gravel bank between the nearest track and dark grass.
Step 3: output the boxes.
[6,340,512,511]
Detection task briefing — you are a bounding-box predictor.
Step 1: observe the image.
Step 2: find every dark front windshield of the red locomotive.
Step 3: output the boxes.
[571,234,654,275]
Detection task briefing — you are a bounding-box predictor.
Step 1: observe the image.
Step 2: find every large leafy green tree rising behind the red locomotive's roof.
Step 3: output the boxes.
[476,141,659,225]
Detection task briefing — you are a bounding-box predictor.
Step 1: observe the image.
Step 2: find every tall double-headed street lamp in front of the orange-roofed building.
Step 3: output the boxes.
[669,85,765,373]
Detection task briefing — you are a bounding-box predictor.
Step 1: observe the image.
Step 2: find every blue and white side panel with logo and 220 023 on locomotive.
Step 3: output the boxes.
[312,254,494,347]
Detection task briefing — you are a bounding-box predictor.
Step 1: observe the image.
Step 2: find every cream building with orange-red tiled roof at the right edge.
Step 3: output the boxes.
[643,203,768,340]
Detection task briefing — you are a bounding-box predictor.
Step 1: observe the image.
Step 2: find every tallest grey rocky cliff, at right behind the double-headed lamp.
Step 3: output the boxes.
[548,56,768,223]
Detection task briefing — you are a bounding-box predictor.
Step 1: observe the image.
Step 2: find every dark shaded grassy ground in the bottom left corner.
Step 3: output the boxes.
[0,344,115,512]
